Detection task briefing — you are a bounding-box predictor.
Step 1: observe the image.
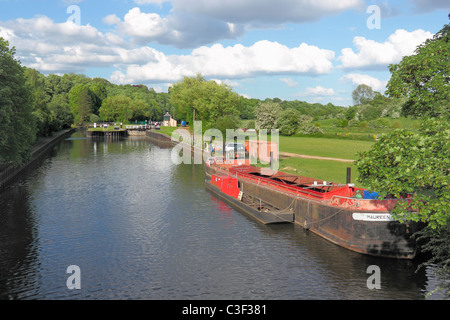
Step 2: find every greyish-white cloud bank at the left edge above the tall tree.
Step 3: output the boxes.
[0,16,158,73]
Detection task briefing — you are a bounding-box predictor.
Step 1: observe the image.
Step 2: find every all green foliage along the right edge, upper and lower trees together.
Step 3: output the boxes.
[356,16,450,296]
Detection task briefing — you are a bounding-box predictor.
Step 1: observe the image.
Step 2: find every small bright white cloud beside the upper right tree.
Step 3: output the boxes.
[338,29,433,69]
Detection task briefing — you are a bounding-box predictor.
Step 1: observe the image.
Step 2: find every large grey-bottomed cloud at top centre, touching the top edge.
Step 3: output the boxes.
[104,0,363,48]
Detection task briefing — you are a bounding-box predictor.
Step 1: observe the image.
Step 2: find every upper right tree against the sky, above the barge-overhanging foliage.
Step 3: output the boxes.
[386,15,450,119]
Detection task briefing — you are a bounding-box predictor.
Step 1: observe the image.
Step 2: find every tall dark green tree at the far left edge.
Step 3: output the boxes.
[0,38,36,166]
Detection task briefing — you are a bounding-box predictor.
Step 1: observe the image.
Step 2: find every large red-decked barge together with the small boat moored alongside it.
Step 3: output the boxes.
[205,158,418,259]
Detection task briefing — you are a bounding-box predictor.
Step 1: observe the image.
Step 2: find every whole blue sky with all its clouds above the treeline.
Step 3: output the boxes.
[0,0,450,106]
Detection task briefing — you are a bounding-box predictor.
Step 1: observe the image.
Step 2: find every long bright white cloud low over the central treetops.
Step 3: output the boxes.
[111,40,334,83]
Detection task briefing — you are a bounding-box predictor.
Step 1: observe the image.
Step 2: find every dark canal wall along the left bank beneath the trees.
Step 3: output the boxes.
[0,128,77,191]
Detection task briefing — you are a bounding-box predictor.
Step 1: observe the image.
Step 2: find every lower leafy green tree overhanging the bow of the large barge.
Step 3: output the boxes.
[356,119,450,228]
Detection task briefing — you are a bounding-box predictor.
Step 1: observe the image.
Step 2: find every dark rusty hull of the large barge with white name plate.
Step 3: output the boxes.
[206,166,418,259]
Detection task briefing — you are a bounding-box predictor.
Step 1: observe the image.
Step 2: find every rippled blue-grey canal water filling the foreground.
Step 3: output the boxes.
[0,132,448,300]
